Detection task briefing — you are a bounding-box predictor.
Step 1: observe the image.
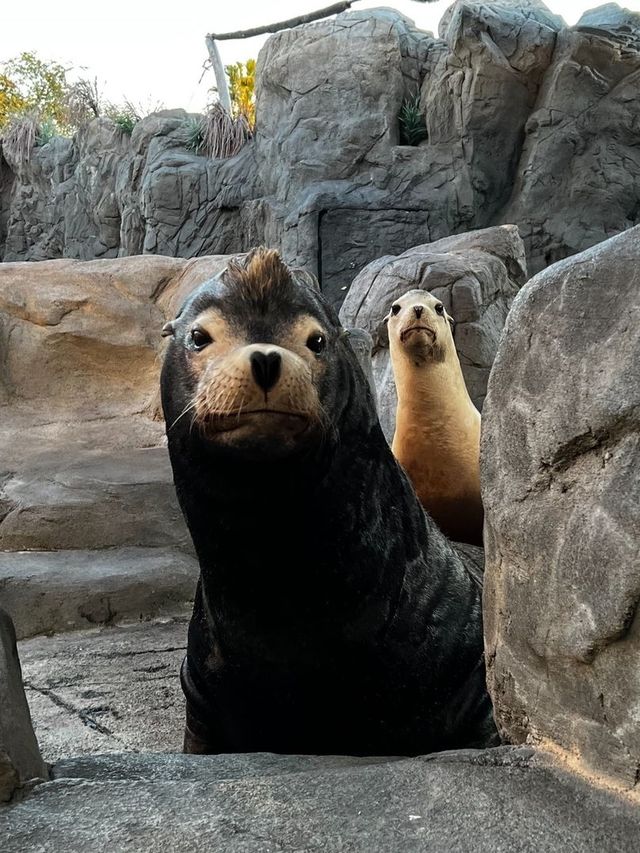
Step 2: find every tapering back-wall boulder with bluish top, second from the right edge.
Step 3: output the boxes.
[428,0,563,225]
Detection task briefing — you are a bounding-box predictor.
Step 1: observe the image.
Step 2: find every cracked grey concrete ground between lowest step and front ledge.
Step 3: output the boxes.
[18,613,188,762]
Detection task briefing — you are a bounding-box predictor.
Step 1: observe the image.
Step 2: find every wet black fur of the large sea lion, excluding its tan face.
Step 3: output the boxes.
[162,250,497,755]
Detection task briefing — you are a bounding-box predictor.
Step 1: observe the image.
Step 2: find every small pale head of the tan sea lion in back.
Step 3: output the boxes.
[387,290,454,362]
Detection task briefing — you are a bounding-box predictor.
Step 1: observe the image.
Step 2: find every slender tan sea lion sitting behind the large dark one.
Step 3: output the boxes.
[388,290,483,545]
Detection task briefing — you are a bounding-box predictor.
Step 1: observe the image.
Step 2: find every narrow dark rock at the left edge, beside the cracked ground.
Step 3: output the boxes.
[0,610,48,803]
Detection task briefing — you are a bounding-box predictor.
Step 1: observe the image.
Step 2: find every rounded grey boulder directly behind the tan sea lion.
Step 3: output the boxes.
[340,225,526,439]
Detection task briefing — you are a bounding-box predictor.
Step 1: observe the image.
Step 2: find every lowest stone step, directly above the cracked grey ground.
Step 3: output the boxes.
[0,547,199,639]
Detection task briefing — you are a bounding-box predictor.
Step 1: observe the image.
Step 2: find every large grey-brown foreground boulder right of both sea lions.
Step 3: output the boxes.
[482,227,640,792]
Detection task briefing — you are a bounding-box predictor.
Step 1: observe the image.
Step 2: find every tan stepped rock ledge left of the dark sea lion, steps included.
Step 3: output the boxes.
[0,256,226,636]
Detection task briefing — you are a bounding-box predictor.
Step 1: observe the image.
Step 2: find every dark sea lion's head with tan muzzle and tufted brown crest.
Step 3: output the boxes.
[162,248,370,457]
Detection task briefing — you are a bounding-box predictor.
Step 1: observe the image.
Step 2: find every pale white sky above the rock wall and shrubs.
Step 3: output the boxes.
[0,0,640,111]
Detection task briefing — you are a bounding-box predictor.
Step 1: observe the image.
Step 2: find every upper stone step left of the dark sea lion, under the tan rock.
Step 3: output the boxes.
[0,446,190,551]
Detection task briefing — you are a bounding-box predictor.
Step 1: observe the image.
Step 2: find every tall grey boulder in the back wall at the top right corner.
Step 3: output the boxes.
[503,3,640,272]
